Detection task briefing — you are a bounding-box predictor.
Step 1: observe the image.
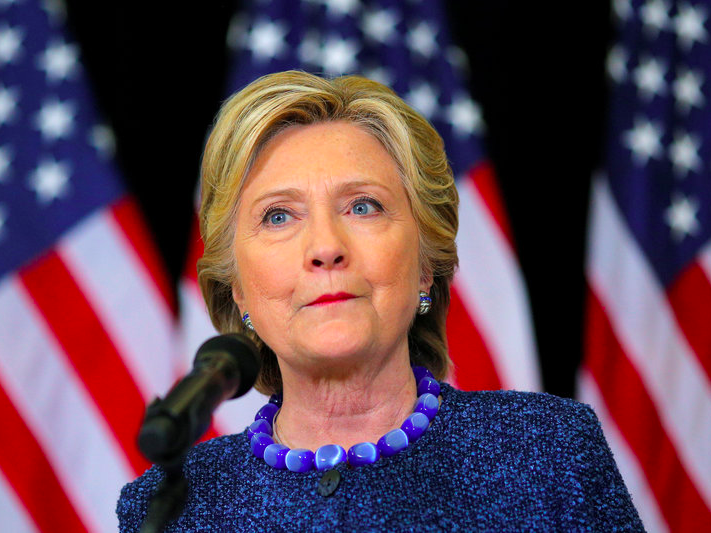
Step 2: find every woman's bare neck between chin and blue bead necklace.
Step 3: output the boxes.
[276,348,417,450]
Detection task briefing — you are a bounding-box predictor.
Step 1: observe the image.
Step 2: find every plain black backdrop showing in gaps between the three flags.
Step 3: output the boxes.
[68,0,612,396]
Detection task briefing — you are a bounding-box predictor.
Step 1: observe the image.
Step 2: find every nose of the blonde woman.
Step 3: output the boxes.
[304,216,348,270]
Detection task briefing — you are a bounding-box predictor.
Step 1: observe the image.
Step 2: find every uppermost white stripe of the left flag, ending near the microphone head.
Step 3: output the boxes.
[57,202,179,401]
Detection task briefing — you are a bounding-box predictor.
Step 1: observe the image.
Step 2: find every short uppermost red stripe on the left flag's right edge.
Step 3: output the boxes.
[111,197,178,315]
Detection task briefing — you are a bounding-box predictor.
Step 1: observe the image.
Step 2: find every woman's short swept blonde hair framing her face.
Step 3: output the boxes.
[197,71,459,394]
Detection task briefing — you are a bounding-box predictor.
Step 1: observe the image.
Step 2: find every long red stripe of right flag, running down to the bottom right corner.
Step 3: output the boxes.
[586,291,711,532]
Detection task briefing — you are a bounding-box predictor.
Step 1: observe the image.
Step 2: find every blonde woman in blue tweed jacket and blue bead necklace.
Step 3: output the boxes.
[118,72,642,531]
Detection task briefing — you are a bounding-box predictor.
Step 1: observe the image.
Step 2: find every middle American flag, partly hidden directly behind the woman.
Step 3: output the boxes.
[181,0,540,438]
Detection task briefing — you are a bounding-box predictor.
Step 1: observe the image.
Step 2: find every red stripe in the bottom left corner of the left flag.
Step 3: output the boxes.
[0,380,87,532]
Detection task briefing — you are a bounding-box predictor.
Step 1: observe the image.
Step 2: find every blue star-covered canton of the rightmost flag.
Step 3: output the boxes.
[607,0,711,285]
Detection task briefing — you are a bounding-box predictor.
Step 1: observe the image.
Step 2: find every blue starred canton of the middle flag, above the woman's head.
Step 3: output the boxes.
[228,0,484,175]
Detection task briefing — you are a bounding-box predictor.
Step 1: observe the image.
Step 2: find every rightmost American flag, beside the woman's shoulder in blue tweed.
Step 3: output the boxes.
[579,0,711,532]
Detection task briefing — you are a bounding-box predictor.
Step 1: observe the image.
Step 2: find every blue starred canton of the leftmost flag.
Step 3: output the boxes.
[0,0,122,276]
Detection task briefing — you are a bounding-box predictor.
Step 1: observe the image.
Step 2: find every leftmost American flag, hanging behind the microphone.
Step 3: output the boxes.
[0,0,179,532]
